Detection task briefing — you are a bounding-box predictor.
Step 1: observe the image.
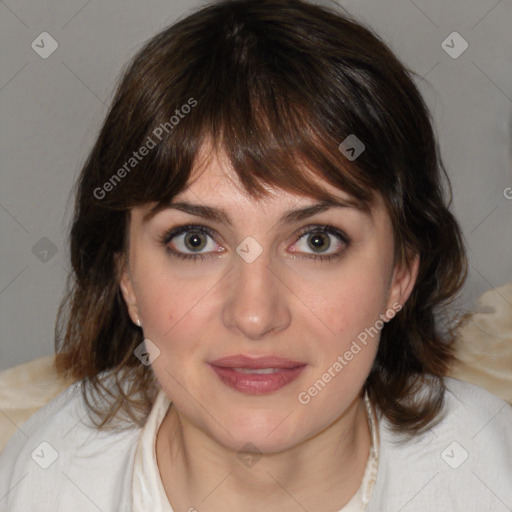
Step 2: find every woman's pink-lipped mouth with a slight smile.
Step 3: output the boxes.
[209,355,307,395]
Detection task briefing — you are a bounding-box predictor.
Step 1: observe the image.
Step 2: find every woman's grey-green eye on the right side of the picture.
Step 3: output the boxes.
[293,225,350,261]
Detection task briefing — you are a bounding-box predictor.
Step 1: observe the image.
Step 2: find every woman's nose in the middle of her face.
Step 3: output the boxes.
[223,251,292,341]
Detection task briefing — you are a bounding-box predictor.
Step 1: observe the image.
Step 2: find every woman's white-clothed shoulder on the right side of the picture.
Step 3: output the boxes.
[369,378,512,512]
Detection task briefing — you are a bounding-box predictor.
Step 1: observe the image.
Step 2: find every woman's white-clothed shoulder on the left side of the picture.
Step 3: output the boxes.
[0,376,141,512]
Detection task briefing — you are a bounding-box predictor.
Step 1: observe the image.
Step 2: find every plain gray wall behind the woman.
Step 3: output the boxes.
[0,0,512,369]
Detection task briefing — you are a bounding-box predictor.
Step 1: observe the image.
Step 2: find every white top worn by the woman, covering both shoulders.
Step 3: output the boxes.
[0,378,512,512]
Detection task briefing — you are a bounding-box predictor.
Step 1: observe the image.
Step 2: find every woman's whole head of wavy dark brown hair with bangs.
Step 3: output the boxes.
[55,0,467,435]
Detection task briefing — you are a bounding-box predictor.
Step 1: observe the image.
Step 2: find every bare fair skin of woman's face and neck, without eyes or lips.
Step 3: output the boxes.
[120,146,419,512]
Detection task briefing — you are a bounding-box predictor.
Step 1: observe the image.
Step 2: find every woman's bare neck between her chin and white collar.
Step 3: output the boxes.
[156,397,371,512]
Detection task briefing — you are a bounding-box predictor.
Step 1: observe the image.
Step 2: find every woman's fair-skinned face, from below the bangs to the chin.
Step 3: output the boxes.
[121,147,418,452]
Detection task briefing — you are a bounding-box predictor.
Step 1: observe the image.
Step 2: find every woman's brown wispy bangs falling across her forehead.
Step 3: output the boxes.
[138,89,372,218]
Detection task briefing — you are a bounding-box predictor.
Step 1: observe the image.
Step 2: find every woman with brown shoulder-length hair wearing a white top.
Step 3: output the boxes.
[0,0,512,512]
